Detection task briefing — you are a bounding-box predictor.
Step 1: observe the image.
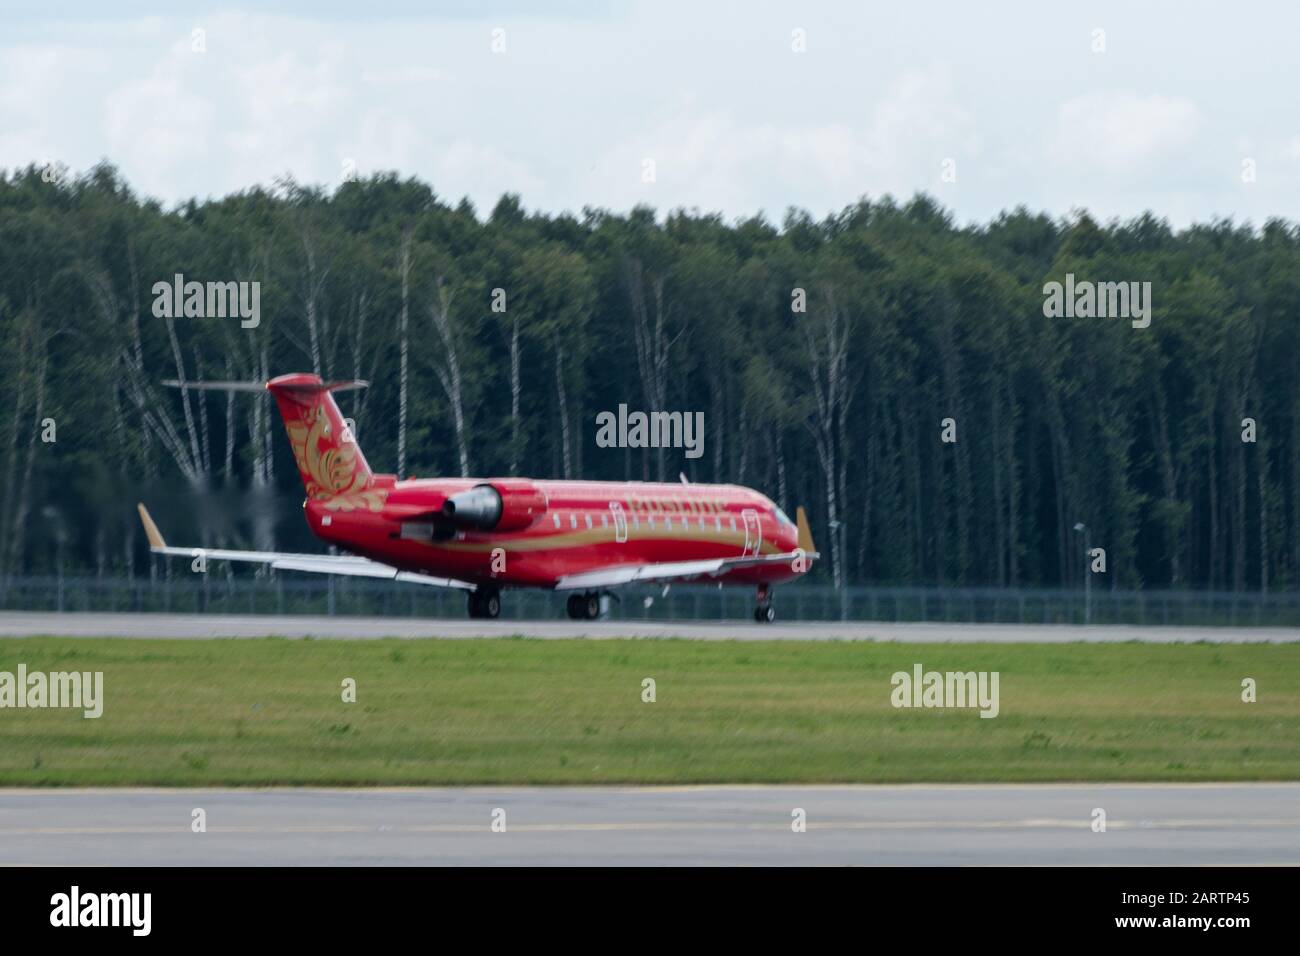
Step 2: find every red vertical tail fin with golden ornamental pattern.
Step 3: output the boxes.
[258,375,374,499]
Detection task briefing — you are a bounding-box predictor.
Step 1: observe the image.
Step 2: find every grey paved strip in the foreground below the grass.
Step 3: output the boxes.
[0,783,1300,866]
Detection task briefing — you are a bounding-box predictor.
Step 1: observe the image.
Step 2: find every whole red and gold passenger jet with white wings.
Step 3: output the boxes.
[138,375,819,622]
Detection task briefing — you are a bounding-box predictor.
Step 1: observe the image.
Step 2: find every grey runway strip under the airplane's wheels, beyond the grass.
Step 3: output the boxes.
[0,611,1300,644]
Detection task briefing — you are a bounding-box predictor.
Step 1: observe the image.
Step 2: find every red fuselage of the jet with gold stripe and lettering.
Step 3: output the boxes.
[304,475,801,588]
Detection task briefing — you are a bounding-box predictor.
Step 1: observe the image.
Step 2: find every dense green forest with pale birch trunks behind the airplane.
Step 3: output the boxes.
[0,164,1300,591]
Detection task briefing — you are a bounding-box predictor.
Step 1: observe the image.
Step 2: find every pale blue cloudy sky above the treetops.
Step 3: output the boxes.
[0,0,1300,228]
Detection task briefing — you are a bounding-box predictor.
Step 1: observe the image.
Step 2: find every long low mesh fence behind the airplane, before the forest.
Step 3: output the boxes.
[0,575,1300,627]
